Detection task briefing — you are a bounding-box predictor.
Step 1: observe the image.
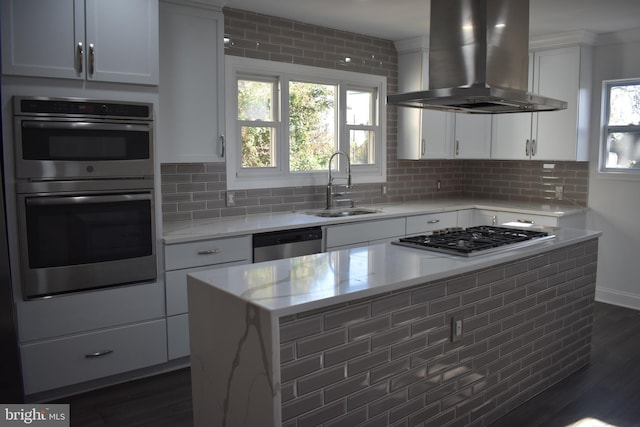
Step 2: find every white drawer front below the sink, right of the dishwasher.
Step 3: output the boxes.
[327,218,406,248]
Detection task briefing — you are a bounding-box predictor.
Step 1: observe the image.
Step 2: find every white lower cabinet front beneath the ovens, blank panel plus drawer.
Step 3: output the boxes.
[15,282,167,395]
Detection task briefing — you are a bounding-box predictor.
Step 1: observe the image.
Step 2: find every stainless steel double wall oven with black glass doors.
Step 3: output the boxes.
[14,97,157,299]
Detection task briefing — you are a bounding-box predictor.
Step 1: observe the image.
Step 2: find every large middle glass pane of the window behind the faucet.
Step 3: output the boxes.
[289,81,337,172]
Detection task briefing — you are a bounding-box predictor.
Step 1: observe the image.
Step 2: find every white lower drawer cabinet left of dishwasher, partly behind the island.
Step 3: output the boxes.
[164,236,253,360]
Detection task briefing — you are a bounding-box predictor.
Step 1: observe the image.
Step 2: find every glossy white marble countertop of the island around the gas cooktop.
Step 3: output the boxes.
[189,228,601,316]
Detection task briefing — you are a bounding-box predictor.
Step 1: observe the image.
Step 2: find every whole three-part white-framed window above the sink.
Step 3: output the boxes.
[225,56,386,189]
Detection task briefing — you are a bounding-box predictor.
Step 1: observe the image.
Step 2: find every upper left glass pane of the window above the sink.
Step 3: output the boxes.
[238,80,275,122]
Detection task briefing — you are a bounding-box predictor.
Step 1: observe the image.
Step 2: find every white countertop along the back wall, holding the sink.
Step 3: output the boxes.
[163,199,587,244]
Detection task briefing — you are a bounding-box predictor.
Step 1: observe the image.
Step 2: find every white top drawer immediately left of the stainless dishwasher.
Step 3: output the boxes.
[164,236,252,270]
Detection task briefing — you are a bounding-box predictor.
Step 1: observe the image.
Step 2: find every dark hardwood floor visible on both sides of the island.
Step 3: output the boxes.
[58,303,640,427]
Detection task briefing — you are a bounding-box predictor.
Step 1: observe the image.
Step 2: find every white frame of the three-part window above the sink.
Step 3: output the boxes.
[225,55,387,190]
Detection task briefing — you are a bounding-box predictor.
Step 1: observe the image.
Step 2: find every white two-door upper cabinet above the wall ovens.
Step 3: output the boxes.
[2,0,159,85]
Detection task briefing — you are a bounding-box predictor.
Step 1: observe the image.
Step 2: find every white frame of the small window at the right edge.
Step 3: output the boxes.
[598,78,640,178]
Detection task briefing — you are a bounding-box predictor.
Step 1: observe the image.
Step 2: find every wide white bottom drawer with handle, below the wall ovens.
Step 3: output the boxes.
[21,319,167,395]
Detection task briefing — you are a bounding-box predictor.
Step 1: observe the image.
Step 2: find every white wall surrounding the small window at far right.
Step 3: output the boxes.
[587,28,640,310]
